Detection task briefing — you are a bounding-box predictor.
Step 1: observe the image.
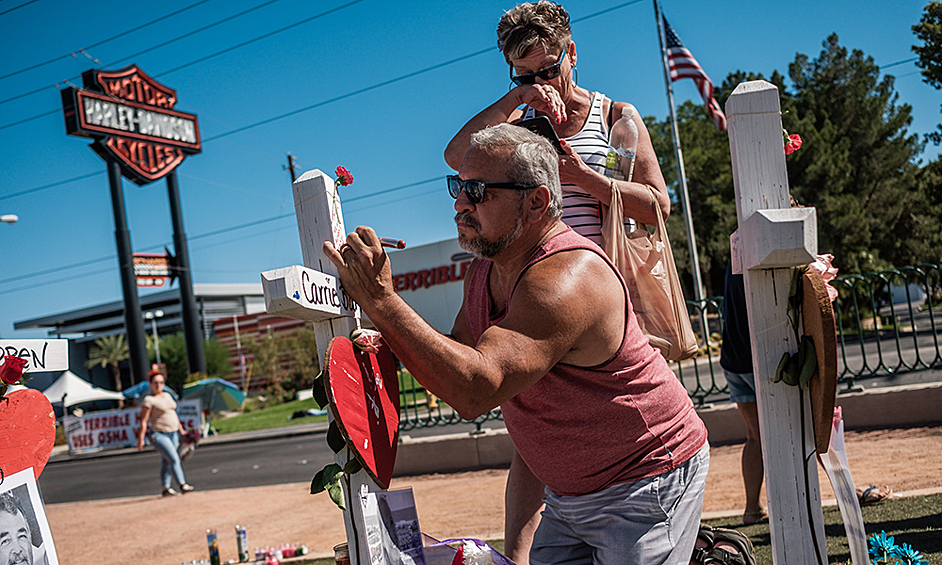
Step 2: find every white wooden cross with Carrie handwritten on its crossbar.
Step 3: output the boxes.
[262,169,383,565]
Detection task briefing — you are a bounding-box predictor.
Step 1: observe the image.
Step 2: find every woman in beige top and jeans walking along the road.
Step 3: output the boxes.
[137,369,193,496]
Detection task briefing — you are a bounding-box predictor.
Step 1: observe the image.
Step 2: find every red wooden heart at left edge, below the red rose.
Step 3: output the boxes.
[0,389,56,479]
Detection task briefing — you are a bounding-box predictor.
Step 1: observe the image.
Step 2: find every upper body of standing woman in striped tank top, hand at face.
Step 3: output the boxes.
[445,0,670,244]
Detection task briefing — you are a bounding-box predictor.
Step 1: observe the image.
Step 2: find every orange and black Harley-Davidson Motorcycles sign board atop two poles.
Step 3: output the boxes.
[61,65,201,185]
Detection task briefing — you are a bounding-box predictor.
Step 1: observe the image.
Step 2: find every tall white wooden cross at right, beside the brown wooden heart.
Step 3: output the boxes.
[726,81,827,565]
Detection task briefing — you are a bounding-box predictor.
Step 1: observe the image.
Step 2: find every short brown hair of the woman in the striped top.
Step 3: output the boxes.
[497,0,572,65]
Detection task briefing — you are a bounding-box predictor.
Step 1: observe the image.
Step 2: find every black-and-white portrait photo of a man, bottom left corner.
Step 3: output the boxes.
[0,468,59,565]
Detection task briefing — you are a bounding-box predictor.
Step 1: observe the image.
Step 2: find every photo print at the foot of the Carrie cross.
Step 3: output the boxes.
[360,489,426,565]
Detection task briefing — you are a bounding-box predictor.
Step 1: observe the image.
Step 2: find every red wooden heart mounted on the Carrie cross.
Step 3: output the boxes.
[324,336,399,488]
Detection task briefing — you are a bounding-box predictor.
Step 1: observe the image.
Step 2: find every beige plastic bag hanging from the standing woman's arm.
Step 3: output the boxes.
[602,183,699,361]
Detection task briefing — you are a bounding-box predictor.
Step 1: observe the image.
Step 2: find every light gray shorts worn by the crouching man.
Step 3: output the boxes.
[530,443,710,565]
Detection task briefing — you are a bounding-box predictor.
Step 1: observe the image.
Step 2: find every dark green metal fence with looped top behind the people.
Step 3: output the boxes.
[399,263,942,430]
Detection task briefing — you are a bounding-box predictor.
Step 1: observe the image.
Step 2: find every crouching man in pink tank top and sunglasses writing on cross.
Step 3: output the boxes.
[324,124,709,564]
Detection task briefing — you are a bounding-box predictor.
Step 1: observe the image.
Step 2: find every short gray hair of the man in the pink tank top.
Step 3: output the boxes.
[471,124,563,218]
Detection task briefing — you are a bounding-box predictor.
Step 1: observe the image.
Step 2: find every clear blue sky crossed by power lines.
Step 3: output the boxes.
[0,0,942,339]
